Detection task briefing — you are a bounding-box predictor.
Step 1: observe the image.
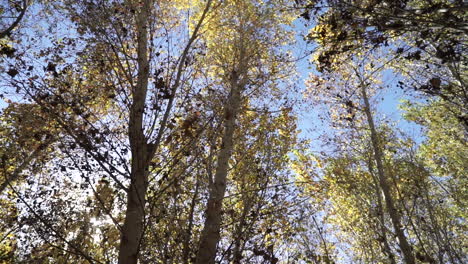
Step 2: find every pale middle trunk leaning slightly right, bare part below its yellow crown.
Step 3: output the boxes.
[195,71,243,264]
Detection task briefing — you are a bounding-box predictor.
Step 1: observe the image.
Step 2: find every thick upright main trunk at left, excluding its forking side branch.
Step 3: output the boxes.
[118,0,151,264]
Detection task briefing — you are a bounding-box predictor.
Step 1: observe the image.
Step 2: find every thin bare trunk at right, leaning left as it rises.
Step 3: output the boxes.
[361,83,415,264]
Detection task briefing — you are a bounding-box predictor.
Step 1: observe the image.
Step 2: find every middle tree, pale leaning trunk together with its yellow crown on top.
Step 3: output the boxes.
[195,0,298,263]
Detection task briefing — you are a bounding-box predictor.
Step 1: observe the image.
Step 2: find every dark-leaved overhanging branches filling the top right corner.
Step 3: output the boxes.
[297,0,467,127]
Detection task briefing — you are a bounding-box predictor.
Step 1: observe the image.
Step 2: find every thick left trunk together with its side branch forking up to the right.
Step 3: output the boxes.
[118,0,213,264]
